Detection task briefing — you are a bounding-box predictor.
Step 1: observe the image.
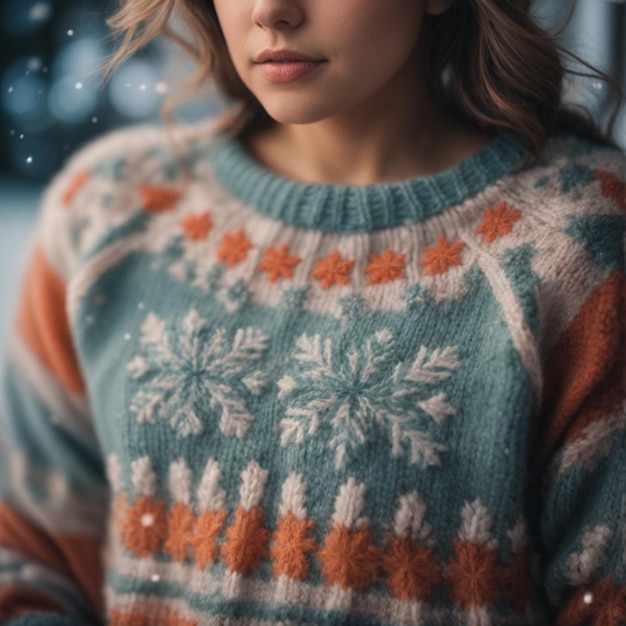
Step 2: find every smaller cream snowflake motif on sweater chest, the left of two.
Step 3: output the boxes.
[127,310,268,438]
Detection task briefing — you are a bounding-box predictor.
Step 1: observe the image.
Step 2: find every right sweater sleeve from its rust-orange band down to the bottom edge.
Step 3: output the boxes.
[542,259,626,626]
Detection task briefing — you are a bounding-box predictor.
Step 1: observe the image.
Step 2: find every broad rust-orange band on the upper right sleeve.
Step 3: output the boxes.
[542,271,626,461]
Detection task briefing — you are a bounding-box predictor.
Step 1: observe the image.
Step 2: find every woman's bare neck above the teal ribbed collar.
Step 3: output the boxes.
[247,64,492,185]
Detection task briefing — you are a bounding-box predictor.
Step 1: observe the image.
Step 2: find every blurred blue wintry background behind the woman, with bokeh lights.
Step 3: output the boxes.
[0,0,626,348]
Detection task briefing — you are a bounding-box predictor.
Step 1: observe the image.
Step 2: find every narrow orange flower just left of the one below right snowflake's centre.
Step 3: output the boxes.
[271,511,317,580]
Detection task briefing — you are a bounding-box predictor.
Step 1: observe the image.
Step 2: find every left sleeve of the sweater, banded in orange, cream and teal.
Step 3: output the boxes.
[0,163,108,626]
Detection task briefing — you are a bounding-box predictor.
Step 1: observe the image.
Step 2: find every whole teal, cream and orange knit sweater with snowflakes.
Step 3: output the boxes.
[0,123,626,626]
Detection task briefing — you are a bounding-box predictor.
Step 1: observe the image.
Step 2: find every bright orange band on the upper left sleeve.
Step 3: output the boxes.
[17,249,85,393]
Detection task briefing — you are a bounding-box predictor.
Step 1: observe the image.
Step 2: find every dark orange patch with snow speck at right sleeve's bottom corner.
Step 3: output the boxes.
[556,578,626,626]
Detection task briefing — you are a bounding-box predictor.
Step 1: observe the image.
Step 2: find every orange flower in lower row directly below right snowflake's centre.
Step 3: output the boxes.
[317,525,380,589]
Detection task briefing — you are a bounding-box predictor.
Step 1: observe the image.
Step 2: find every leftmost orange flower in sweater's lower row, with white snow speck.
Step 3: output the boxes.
[120,498,167,557]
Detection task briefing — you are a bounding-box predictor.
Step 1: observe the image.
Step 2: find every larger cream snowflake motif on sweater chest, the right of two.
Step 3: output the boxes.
[278,330,460,468]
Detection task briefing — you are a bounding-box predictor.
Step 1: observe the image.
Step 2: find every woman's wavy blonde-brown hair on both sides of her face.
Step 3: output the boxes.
[107,0,622,159]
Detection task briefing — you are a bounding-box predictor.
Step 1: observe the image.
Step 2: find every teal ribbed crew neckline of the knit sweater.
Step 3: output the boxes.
[209,137,527,233]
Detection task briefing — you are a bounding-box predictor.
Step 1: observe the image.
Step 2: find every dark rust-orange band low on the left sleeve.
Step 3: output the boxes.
[0,504,104,617]
